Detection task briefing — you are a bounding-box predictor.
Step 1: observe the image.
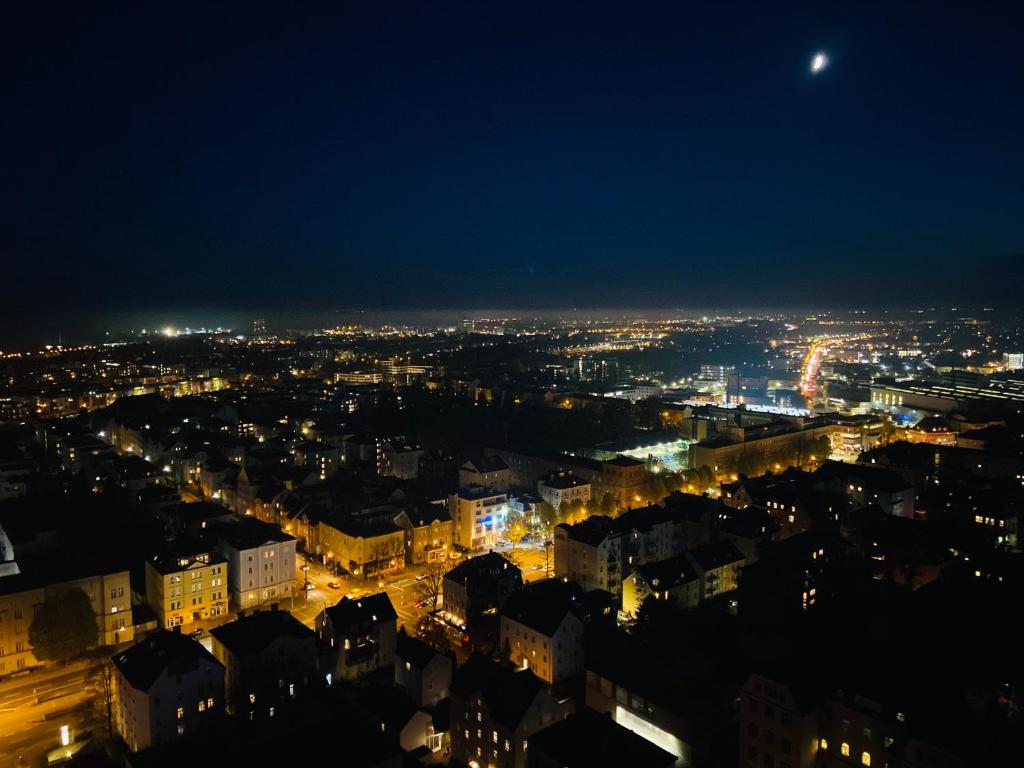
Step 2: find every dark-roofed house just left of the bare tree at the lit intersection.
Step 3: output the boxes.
[316,592,398,682]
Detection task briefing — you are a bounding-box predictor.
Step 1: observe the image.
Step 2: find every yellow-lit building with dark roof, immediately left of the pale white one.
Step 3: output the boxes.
[145,540,230,629]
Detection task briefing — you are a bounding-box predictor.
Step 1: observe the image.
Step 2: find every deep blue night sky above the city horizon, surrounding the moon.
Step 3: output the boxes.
[0,0,1024,322]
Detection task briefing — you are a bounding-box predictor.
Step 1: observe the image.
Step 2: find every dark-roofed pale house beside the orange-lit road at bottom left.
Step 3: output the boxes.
[113,631,224,752]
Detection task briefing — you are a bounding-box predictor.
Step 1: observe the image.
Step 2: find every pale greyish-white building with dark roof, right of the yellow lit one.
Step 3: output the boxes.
[216,517,296,609]
